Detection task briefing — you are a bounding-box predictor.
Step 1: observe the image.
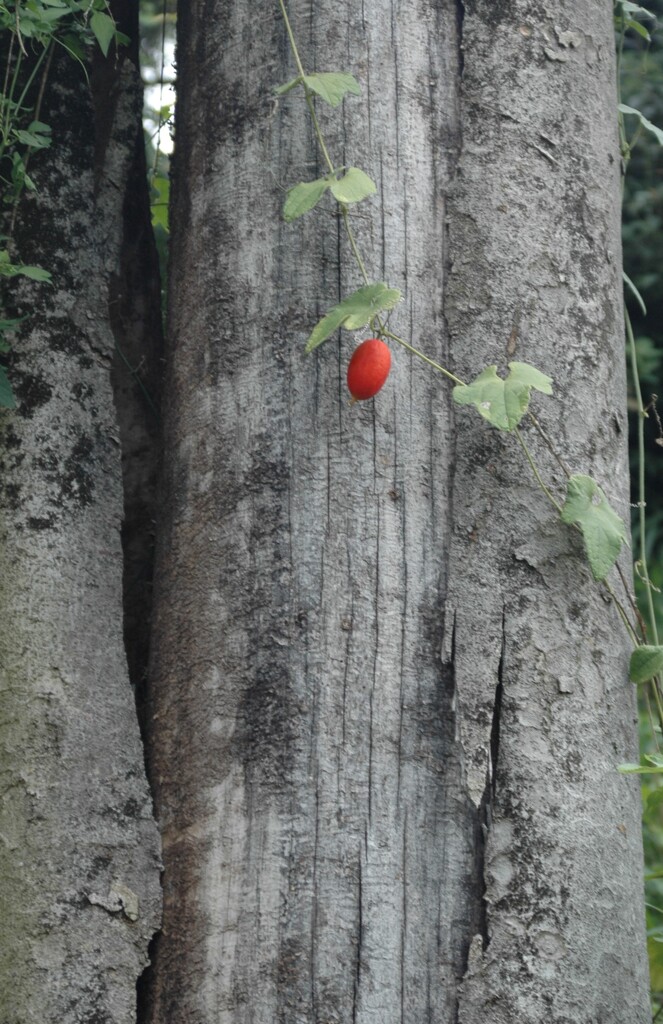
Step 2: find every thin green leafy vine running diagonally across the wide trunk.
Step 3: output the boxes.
[275,0,663,704]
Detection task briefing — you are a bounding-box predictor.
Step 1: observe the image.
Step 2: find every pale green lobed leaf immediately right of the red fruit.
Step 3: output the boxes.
[453,362,552,430]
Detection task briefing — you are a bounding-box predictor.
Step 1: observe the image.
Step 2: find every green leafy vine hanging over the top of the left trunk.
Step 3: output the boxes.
[0,0,128,409]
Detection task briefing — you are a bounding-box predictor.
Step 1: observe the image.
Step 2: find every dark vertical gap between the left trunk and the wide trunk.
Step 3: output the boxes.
[94,34,163,1024]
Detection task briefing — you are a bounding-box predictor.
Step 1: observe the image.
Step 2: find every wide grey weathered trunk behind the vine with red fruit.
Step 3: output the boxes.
[148,0,647,1024]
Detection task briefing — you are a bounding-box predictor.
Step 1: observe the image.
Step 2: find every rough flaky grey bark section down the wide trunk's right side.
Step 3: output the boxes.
[445,2,650,1024]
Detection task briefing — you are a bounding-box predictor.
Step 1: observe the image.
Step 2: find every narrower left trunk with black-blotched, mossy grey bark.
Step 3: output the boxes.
[0,36,160,1024]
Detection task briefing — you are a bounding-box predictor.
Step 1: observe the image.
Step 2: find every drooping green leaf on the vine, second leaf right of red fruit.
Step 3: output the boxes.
[561,475,626,580]
